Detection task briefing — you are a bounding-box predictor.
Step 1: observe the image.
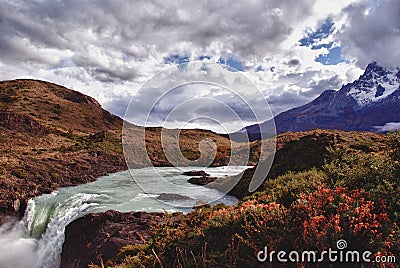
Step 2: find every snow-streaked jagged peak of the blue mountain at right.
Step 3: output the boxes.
[344,62,400,107]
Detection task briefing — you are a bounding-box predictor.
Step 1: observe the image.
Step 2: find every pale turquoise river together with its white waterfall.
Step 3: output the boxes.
[0,167,246,268]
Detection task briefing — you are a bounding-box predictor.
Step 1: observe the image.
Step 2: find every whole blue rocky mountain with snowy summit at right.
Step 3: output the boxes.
[241,62,400,140]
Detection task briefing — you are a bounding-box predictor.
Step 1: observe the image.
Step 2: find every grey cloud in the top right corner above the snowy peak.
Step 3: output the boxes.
[341,0,400,67]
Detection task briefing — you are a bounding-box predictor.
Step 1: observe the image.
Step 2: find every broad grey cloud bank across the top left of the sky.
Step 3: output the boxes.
[0,0,313,70]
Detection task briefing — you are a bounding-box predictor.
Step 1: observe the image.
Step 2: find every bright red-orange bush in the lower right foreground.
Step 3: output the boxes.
[290,188,399,255]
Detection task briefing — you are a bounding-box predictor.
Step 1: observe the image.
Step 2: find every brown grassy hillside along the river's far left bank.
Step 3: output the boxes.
[0,79,247,218]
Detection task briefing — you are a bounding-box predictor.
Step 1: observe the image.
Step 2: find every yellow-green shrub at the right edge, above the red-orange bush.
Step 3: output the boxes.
[323,144,400,222]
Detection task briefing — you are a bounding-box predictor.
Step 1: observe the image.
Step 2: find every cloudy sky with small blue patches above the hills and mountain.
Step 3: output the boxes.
[0,0,400,132]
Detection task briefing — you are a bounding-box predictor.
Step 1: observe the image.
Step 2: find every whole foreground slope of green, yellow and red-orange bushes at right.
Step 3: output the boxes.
[106,132,400,268]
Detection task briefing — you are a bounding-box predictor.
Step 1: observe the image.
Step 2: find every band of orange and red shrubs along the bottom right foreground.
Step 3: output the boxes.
[111,187,400,267]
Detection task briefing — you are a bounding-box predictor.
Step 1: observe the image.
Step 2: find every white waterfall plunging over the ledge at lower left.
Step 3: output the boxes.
[0,192,100,268]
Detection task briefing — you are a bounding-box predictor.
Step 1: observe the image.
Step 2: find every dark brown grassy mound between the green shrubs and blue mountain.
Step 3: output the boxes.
[226,129,387,198]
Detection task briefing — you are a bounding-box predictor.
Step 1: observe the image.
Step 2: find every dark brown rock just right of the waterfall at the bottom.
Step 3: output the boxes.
[60,210,165,268]
